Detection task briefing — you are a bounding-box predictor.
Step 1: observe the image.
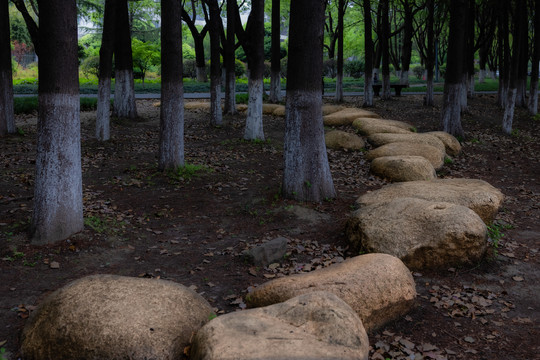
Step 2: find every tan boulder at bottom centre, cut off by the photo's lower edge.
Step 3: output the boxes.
[190,292,369,360]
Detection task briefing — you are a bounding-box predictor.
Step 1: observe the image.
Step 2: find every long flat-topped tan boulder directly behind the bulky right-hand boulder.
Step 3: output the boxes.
[356,179,504,224]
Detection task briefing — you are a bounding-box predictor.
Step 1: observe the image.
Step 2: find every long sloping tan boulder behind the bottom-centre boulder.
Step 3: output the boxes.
[246,254,416,333]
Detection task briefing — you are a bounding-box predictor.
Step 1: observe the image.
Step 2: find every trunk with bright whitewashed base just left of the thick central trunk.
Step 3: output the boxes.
[244,0,264,140]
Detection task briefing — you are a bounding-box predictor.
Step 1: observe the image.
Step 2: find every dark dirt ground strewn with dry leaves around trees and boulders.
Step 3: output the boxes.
[0,95,540,360]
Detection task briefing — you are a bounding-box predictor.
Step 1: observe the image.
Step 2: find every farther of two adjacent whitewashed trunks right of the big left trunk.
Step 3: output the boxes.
[113,0,137,119]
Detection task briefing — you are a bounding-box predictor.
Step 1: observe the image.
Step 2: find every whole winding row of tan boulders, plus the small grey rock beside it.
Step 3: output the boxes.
[21,105,503,360]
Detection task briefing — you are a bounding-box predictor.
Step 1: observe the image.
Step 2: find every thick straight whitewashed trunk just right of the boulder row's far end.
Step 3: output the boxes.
[441,0,468,137]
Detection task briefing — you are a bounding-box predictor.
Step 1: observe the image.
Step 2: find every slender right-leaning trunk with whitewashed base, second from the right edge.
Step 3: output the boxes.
[502,0,527,135]
